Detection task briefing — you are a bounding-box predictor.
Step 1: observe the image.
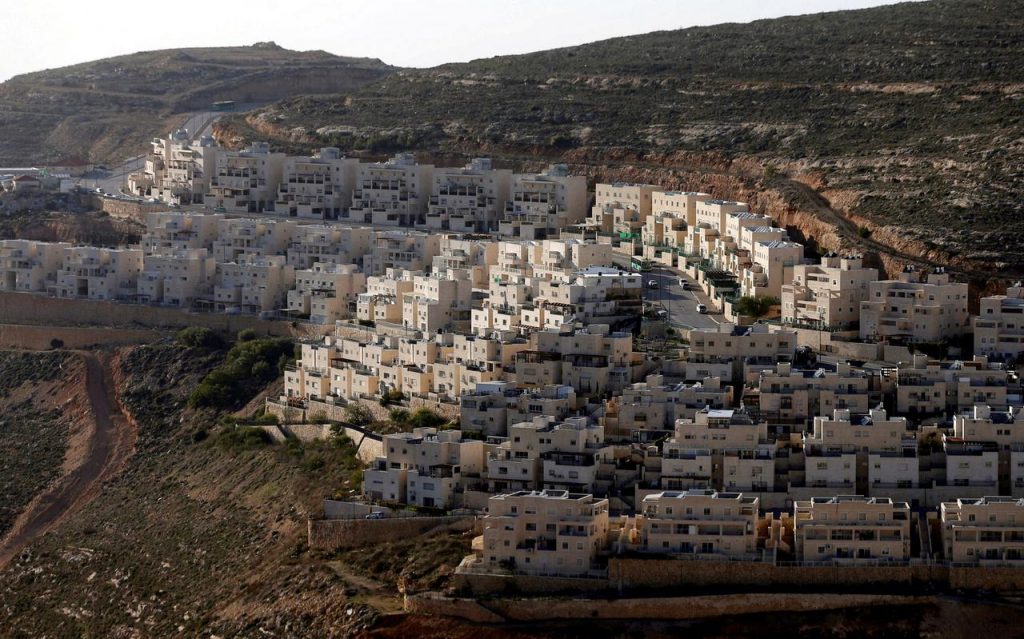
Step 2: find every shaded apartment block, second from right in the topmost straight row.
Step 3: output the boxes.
[423,158,512,232]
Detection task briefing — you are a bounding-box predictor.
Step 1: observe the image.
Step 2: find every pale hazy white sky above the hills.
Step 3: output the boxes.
[6,0,921,80]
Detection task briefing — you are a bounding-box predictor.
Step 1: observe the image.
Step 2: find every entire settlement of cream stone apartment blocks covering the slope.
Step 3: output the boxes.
[9,133,1024,576]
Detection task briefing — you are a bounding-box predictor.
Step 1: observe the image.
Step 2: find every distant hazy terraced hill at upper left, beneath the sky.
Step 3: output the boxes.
[0,43,392,166]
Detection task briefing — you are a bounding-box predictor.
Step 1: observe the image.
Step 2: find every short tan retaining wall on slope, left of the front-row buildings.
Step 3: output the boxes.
[308,516,476,550]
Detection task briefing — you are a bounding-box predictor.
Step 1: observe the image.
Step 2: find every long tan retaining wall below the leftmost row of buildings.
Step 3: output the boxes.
[0,291,293,336]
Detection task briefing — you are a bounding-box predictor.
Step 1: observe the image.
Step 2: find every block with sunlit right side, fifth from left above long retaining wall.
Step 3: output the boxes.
[287,262,367,324]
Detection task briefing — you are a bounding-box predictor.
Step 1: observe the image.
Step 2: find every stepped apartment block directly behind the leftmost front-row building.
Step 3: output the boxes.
[487,415,606,493]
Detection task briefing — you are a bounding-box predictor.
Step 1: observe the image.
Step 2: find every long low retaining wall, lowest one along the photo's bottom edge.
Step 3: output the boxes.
[406,593,935,624]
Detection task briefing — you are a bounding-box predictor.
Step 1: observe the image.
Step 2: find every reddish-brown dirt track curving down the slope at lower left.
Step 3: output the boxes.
[0,351,137,568]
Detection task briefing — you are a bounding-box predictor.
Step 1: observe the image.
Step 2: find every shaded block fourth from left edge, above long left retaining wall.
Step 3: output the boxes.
[213,255,295,312]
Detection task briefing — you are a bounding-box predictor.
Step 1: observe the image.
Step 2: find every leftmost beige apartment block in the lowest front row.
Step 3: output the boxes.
[477,491,608,577]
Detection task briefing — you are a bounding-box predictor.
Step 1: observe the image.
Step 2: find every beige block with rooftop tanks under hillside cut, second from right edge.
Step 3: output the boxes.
[860,266,970,342]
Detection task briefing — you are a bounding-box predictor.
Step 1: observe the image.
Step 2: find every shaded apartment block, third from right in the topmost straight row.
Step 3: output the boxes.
[342,154,434,228]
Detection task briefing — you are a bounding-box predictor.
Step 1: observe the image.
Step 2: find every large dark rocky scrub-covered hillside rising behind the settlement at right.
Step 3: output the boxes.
[218,0,1024,284]
